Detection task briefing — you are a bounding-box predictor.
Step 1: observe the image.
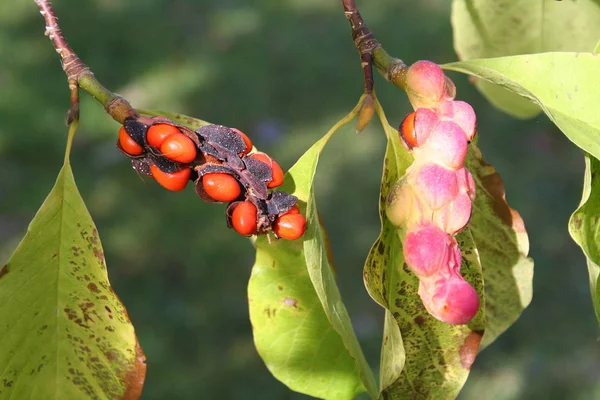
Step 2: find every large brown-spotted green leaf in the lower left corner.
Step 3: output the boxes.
[0,123,146,400]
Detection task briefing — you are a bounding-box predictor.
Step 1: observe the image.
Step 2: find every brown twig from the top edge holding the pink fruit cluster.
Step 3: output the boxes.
[342,0,407,90]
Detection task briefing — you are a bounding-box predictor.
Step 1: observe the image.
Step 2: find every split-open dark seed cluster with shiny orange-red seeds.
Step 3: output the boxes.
[117,117,306,240]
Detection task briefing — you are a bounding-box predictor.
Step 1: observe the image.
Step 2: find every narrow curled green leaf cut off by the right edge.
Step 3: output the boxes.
[569,155,600,323]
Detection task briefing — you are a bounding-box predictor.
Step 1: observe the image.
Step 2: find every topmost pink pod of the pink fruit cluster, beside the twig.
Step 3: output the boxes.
[406,61,446,109]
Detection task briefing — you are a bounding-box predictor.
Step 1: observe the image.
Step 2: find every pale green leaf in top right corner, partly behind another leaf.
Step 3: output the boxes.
[452,0,600,118]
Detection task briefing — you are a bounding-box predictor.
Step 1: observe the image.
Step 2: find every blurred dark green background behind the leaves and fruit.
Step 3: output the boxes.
[0,0,600,400]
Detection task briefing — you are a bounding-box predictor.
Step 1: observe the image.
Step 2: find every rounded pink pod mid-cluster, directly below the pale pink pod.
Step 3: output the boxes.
[407,162,458,211]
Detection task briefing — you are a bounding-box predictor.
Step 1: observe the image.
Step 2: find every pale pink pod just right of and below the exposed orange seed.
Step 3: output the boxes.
[415,121,468,170]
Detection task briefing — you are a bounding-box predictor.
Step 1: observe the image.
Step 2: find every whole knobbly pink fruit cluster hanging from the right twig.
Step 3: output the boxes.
[386,61,479,325]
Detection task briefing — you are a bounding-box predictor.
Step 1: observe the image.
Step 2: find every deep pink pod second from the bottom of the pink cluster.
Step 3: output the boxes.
[403,223,451,278]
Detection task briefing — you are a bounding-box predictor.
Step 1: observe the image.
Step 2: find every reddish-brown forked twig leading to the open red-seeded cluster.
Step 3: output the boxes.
[34,0,138,124]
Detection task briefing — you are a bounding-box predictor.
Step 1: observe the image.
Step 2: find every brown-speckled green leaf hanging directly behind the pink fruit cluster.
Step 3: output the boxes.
[363,103,485,399]
